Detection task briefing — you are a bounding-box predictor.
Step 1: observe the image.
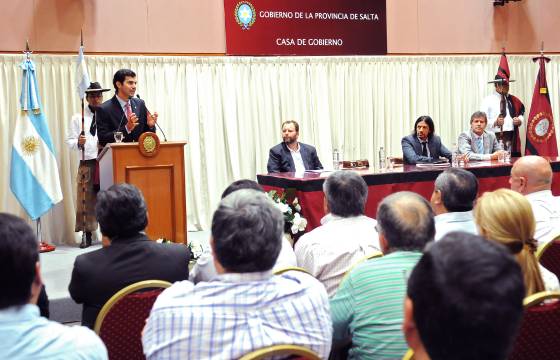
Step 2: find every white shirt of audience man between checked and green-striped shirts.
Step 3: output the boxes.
[295,214,380,297]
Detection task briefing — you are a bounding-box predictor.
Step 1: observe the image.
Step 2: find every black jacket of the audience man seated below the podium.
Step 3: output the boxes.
[68,234,190,328]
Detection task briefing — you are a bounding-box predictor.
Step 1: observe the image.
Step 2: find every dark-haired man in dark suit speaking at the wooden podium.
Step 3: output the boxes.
[96,69,158,146]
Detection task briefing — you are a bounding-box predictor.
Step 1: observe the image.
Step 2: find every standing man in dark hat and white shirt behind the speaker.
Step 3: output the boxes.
[66,82,110,249]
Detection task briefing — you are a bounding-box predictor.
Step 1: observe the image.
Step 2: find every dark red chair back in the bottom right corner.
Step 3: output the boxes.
[509,291,560,360]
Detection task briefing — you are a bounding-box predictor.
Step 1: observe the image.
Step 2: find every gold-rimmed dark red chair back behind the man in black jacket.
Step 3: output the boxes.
[94,280,171,360]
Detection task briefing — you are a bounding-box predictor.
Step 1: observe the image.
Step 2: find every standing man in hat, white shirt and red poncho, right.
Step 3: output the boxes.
[481,54,525,157]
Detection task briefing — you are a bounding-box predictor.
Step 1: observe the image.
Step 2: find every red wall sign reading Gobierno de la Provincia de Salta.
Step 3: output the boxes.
[224,0,387,55]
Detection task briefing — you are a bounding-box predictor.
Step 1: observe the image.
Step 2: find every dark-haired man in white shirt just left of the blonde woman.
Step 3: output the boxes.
[430,168,478,241]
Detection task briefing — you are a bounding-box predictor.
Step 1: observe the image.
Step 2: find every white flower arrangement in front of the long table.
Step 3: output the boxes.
[267,189,307,236]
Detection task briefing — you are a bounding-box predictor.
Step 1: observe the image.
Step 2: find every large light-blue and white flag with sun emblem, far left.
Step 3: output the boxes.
[10,59,62,220]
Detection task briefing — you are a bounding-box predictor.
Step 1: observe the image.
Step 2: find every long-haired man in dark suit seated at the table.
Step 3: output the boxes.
[401,116,451,164]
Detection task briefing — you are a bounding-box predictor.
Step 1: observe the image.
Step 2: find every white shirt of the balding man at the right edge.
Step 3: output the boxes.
[525,190,560,245]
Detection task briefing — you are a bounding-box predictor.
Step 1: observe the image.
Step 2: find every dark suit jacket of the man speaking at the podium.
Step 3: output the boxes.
[95,95,156,146]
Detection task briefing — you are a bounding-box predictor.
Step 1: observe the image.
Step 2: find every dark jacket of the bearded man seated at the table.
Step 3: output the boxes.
[266,143,323,173]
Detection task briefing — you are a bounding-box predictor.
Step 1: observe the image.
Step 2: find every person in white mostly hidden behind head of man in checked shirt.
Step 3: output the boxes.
[189,179,297,284]
